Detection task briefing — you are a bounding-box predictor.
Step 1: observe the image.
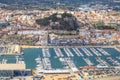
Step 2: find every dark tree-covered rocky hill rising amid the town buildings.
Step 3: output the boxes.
[36,13,79,31]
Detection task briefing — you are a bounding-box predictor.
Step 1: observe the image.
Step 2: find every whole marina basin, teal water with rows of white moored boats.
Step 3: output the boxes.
[0,47,120,71]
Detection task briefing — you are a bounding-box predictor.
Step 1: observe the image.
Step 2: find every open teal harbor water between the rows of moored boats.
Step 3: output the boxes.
[0,48,120,69]
